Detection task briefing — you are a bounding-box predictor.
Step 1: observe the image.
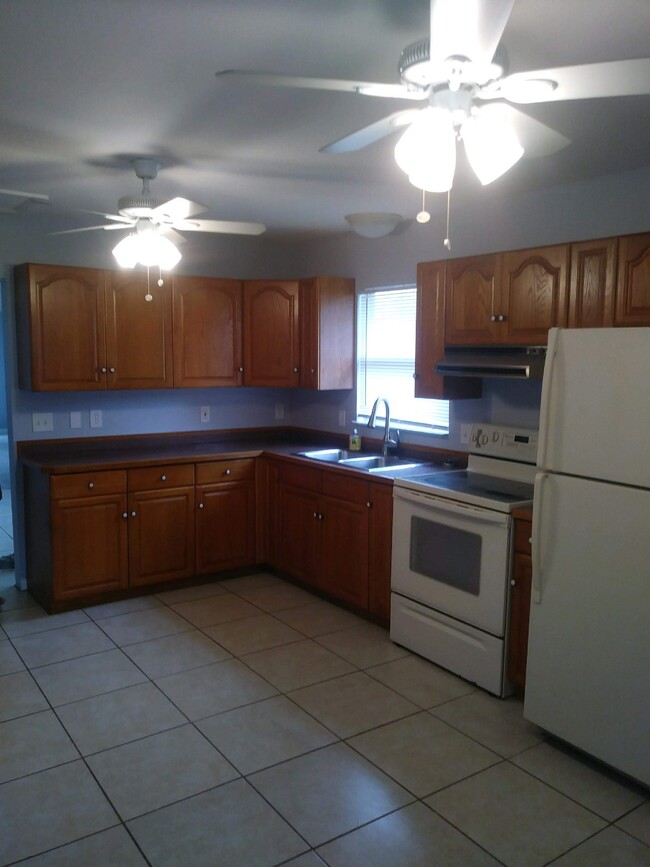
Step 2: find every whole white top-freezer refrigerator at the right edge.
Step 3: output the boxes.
[524,328,650,785]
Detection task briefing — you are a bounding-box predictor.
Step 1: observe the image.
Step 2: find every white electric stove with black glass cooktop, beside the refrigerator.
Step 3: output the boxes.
[390,425,537,696]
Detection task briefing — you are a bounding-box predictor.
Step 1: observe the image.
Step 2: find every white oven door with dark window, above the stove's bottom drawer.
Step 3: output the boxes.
[391,487,512,637]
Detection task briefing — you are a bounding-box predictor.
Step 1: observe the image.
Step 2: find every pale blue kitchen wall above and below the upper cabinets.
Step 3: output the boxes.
[0,1,648,867]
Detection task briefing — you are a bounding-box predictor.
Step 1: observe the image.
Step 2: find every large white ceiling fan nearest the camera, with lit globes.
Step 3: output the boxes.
[217,0,650,192]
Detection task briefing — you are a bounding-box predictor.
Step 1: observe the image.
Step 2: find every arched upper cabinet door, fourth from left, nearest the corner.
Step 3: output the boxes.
[244,280,300,388]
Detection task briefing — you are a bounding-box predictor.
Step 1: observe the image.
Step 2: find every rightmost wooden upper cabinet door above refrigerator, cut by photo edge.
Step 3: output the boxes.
[614,233,650,325]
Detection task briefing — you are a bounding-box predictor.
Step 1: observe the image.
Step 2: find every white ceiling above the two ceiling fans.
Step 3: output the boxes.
[0,0,650,237]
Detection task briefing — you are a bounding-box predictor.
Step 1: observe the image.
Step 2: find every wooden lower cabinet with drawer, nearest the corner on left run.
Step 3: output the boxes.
[196,458,255,575]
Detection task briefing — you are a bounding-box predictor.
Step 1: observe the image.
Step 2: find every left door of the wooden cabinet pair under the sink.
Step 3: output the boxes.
[276,482,321,586]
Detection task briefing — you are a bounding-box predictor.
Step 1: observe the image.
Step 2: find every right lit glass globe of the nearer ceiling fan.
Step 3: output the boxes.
[461,105,524,186]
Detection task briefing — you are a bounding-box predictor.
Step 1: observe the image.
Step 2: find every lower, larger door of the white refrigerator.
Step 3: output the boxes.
[524,474,650,785]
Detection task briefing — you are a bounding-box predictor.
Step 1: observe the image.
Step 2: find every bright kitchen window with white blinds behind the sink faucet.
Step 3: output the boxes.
[357,286,449,434]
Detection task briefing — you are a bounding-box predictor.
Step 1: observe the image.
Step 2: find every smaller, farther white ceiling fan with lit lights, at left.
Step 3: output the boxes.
[52,157,266,269]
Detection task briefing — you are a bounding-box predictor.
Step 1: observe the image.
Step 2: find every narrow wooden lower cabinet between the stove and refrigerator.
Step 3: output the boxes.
[508,519,533,691]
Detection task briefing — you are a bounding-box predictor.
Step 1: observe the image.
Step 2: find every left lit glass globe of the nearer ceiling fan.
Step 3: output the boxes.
[395,106,456,185]
